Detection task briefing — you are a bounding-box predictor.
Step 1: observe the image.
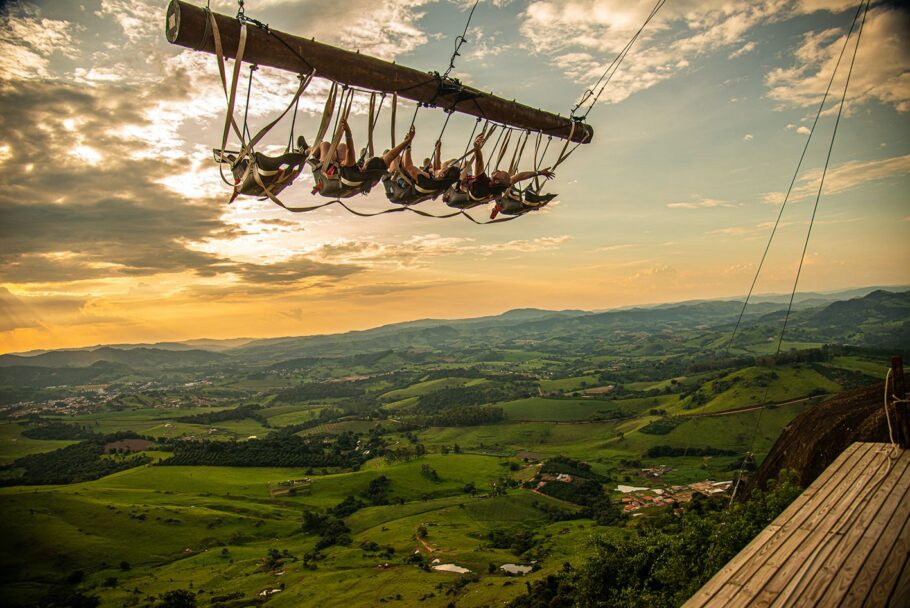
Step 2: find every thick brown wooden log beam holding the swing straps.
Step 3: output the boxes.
[165,0,594,143]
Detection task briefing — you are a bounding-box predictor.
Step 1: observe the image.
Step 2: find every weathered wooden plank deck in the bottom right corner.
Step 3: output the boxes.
[684,443,910,608]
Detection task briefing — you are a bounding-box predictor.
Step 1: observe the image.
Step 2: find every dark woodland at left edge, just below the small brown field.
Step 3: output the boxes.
[0,433,151,486]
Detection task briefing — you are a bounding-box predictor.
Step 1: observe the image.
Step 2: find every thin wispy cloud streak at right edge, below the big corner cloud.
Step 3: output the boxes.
[764,154,910,205]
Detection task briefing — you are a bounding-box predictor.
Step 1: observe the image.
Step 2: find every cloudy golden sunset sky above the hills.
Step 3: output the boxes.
[0,0,910,352]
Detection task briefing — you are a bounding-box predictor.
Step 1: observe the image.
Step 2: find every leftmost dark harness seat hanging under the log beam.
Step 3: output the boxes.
[212,150,307,202]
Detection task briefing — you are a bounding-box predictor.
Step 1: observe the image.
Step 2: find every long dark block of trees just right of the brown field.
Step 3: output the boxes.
[159,435,362,468]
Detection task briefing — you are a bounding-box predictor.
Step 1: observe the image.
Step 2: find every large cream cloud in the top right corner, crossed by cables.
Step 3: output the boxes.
[765,6,910,112]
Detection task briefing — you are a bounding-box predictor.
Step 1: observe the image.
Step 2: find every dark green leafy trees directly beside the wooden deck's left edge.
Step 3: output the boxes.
[509,473,800,608]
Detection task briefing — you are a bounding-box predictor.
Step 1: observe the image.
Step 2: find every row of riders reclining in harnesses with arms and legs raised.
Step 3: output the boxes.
[249,119,555,217]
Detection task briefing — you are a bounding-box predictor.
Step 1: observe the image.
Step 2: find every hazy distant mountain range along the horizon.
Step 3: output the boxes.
[0,288,910,372]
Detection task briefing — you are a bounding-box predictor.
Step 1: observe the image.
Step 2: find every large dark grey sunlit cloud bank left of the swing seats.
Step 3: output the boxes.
[0,81,358,285]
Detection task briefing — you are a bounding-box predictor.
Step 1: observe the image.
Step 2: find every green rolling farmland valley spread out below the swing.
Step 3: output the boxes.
[0,295,903,607]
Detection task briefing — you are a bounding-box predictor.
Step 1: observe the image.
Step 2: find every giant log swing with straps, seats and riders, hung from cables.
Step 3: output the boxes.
[167,0,665,224]
